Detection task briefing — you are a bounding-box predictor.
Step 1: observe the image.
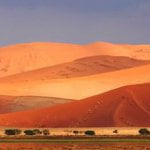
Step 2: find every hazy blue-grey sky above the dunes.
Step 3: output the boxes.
[0,0,150,45]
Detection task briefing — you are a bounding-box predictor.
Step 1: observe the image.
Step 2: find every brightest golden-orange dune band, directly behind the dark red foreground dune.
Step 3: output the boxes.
[0,65,150,99]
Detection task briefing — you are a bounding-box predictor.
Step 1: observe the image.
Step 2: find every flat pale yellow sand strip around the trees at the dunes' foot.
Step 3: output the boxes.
[0,127,150,136]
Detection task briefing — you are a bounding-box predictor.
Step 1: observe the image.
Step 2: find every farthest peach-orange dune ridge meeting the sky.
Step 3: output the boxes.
[0,42,150,77]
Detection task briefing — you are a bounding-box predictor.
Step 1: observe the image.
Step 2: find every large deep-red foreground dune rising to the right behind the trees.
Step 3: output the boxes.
[0,83,150,127]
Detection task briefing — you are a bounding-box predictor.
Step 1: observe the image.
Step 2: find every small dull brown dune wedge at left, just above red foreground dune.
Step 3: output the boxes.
[0,95,73,114]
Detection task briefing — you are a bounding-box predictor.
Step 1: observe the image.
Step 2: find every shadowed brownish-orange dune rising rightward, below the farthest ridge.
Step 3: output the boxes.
[0,55,150,82]
